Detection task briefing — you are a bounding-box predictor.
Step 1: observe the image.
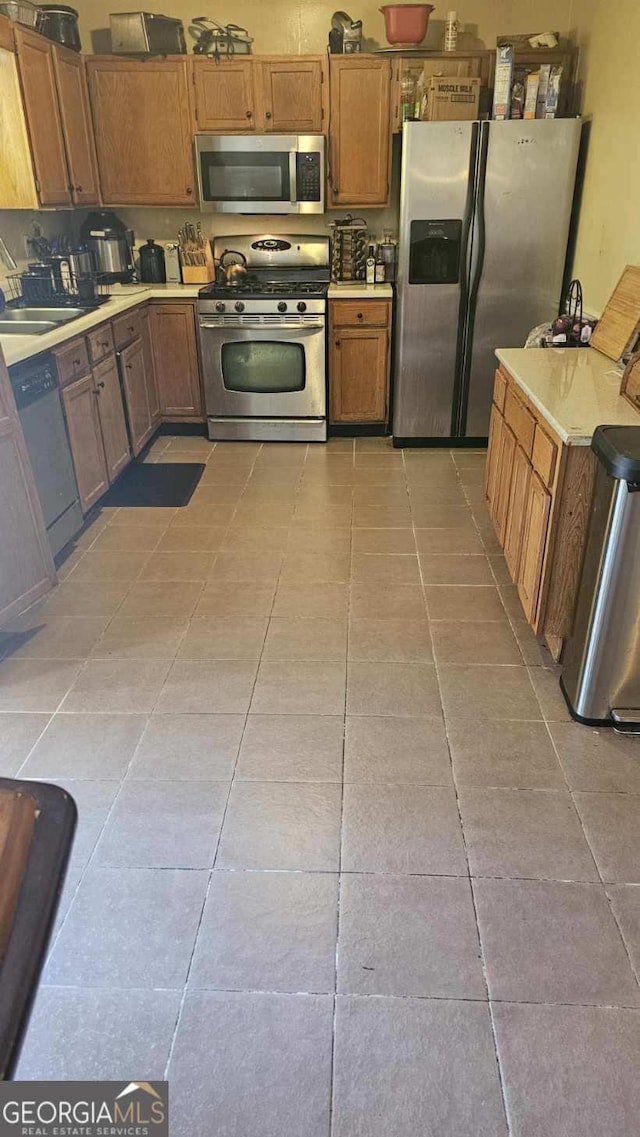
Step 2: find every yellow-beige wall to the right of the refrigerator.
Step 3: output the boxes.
[566,0,640,314]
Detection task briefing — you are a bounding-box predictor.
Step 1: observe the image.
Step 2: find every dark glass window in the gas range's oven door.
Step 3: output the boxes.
[222,340,306,395]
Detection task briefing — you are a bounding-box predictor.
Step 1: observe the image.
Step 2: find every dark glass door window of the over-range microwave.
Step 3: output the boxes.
[200,150,291,201]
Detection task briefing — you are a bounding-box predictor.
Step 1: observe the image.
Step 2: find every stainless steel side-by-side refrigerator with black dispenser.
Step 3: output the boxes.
[393,118,582,445]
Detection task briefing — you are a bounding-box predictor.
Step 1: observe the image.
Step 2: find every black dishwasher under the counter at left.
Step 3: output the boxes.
[9,355,83,556]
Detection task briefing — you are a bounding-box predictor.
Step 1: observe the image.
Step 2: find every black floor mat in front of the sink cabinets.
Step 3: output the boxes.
[100,462,205,509]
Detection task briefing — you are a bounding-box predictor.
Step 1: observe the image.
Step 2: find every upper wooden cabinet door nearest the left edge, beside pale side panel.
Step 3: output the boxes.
[15,26,72,206]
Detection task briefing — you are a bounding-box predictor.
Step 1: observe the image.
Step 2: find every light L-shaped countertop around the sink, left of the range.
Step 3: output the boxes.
[0,284,202,367]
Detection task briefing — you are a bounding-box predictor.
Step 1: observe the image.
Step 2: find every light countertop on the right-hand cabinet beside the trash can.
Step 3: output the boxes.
[496,348,640,446]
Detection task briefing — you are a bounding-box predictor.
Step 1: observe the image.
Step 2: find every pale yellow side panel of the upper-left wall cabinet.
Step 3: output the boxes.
[0,44,39,209]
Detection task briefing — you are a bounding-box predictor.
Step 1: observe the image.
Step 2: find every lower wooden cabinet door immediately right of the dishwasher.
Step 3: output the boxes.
[60,375,109,513]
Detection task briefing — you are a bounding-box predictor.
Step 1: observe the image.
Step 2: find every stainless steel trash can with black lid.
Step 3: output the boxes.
[560,426,640,735]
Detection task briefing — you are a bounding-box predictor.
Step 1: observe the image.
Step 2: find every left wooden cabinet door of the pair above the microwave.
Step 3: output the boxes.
[192,59,256,132]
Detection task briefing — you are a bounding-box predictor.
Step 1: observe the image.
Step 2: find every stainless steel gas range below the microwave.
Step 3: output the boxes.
[198,234,330,442]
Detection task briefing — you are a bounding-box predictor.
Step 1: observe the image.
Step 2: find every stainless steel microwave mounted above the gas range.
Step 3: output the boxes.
[196,134,324,214]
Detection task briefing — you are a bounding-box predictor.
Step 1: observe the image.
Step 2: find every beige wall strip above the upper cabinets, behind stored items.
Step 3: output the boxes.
[75,0,575,55]
